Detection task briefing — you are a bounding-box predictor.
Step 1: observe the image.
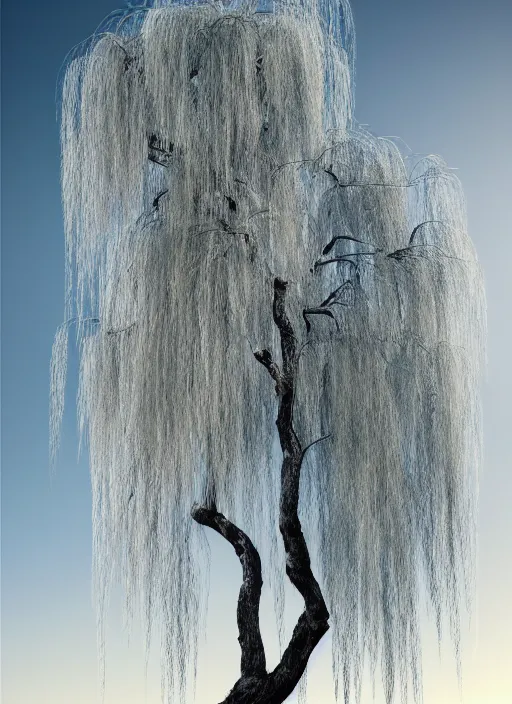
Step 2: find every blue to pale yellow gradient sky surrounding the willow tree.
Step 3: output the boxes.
[2,0,512,704]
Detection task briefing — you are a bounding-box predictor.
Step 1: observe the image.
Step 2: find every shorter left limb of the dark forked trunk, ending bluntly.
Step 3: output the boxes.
[191,504,266,678]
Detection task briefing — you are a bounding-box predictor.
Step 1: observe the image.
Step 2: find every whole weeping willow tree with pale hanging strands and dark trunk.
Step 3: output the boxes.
[51,0,484,704]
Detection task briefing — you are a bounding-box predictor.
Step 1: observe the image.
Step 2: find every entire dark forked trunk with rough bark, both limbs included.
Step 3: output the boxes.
[192,279,329,704]
